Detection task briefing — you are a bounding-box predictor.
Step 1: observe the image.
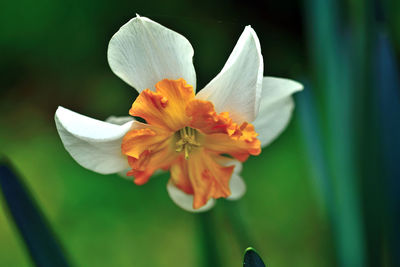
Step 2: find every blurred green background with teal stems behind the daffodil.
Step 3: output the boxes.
[0,0,400,267]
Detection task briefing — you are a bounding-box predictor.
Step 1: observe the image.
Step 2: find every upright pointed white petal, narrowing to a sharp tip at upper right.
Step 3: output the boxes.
[197,26,264,123]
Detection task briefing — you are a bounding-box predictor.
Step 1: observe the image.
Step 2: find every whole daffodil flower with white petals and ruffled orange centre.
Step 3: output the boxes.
[55,16,302,214]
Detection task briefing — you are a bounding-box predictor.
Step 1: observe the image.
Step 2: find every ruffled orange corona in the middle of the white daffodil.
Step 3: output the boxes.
[121,79,261,209]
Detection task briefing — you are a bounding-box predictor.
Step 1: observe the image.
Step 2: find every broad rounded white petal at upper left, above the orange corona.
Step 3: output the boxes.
[108,16,196,92]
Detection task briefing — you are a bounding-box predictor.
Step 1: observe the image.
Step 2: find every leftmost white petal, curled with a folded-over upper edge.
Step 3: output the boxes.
[55,107,137,174]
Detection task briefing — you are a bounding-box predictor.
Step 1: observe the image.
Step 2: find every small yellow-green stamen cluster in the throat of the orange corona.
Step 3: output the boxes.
[175,127,200,160]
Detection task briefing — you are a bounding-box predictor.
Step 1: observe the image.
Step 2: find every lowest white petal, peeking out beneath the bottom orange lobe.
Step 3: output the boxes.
[167,182,215,212]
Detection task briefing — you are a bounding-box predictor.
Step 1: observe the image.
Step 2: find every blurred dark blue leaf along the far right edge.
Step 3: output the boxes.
[371,28,400,266]
